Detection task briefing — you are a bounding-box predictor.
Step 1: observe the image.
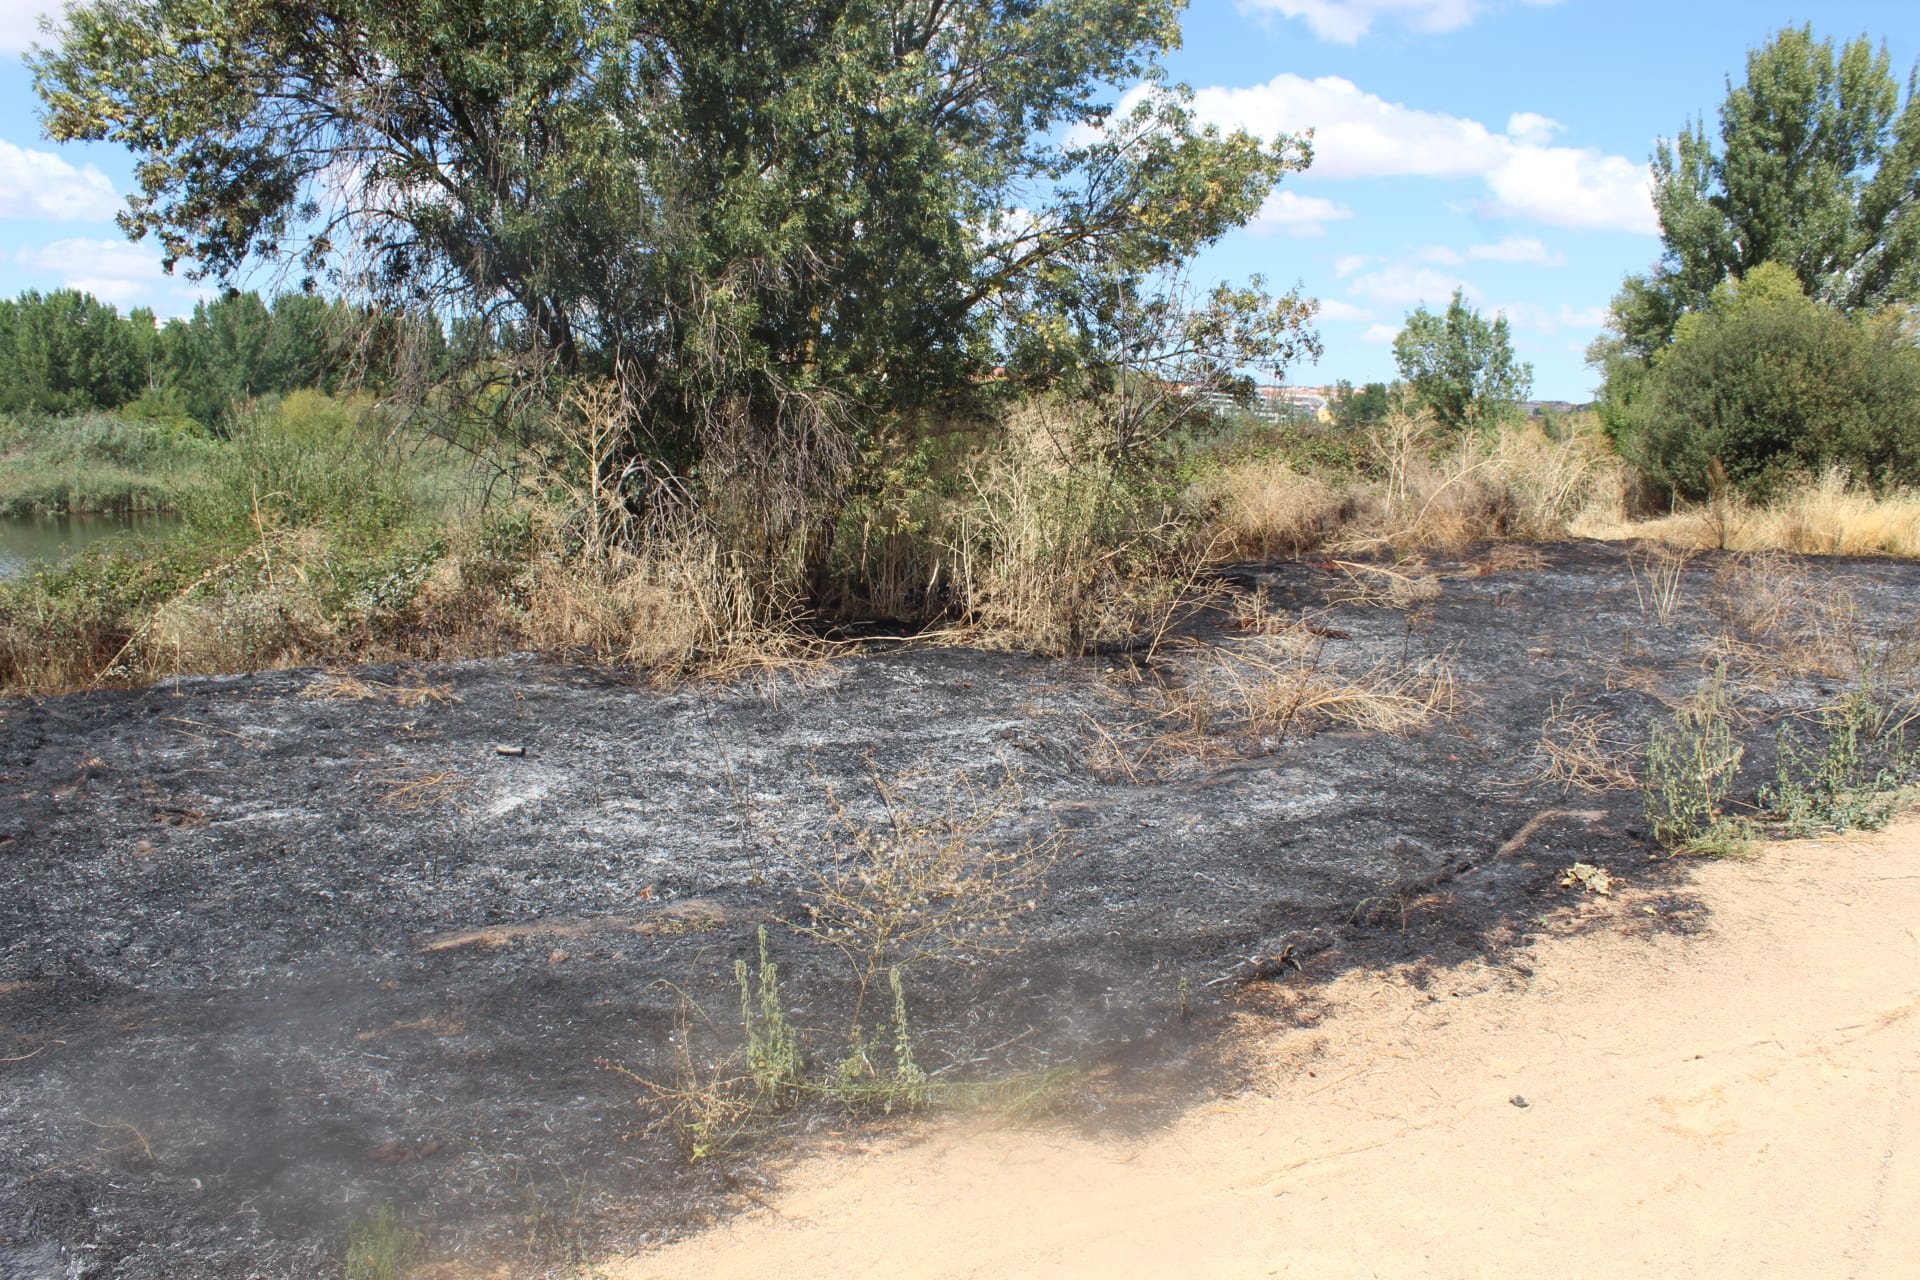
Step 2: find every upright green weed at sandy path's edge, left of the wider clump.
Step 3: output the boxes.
[1645,662,1747,854]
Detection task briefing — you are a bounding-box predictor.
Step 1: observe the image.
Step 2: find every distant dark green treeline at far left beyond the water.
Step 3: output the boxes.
[0,290,445,428]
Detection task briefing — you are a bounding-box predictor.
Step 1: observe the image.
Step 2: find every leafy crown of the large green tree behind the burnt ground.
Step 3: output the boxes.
[31,0,1309,506]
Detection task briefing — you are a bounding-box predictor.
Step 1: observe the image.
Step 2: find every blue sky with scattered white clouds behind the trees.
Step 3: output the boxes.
[0,0,1920,399]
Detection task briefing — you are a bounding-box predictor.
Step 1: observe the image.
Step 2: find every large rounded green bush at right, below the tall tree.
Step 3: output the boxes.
[1613,263,1920,497]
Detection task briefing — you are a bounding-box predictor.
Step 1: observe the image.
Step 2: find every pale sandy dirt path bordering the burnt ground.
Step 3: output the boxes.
[605,821,1920,1280]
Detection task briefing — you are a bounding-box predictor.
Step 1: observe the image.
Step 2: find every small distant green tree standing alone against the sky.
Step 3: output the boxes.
[1394,290,1534,432]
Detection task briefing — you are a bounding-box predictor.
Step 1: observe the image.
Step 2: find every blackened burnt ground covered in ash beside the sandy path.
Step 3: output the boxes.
[0,545,1920,1280]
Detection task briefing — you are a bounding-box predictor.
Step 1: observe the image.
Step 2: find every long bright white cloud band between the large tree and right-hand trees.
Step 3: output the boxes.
[1175,73,1659,234]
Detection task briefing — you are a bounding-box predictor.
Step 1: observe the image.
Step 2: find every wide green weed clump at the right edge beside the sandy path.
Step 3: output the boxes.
[1761,666,1920,837]
